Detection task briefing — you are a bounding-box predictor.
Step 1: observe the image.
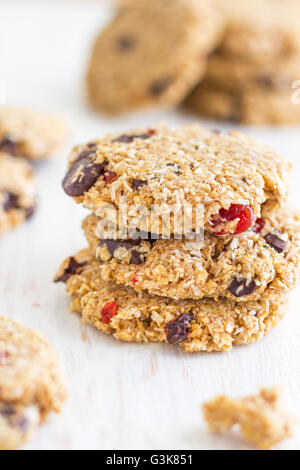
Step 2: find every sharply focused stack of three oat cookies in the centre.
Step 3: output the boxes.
[55,125,300,352]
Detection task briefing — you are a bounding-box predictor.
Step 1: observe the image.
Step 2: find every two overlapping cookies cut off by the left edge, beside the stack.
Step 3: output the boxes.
[0,105,66,235]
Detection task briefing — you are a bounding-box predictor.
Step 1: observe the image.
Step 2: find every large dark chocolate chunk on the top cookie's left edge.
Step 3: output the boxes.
[62,150,105,196]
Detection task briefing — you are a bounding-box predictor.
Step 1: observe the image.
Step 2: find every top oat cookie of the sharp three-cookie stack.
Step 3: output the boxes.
[63,125,291,236]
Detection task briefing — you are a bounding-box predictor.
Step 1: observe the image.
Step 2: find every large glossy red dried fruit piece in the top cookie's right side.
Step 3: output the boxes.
[211,204,254,235]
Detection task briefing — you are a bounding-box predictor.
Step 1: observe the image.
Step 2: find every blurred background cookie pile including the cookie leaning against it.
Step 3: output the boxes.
[87,0,300,124]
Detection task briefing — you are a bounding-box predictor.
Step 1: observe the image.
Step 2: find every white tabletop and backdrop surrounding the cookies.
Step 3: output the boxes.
[0,0,300,449]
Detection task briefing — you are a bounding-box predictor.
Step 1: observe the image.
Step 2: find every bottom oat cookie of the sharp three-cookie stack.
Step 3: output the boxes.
[55,249,287,353]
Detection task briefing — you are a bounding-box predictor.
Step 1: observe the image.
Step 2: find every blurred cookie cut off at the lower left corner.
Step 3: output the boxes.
[0,317,66,450]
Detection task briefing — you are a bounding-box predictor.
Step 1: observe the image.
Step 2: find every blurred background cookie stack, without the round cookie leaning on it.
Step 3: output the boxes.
[186,0,300,124]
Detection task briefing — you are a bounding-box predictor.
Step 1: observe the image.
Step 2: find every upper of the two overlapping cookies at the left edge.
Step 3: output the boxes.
[0,105,67,160]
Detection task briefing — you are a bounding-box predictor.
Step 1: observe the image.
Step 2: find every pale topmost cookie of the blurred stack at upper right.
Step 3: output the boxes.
[214,0,300,64]
